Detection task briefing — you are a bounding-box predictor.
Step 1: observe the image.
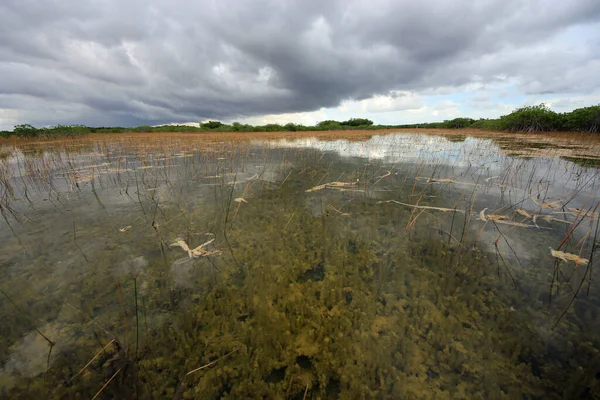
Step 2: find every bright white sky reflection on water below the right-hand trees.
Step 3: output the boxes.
[256,133,598,209]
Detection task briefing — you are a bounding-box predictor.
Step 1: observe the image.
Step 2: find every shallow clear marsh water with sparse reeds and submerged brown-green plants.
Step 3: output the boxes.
[0,133,600,399]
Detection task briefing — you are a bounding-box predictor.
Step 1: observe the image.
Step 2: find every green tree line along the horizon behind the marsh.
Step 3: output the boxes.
[0,104,600,138]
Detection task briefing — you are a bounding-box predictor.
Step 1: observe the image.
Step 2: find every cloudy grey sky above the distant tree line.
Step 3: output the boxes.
[0,0,600,130]
